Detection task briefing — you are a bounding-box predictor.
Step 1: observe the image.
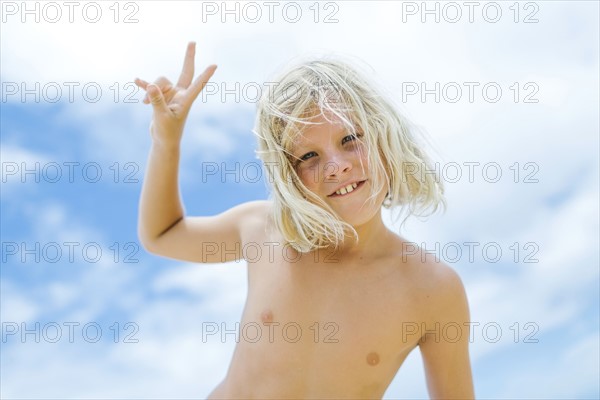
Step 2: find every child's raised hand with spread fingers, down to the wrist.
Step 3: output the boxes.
[135,42,217,145]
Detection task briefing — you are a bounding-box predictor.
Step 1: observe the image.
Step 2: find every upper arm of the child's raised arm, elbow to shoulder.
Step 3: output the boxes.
[144,200,268,263]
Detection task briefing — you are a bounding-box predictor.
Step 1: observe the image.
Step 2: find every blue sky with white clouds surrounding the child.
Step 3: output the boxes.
[0,1,600,399]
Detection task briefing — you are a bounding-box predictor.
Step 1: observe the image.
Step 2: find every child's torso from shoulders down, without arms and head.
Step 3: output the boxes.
[209,203,434,399]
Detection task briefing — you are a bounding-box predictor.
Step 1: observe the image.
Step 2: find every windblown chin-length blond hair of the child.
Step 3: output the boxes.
[253,56,446,252]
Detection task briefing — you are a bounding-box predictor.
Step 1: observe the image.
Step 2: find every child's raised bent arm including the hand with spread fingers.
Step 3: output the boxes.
[136,43,263,262]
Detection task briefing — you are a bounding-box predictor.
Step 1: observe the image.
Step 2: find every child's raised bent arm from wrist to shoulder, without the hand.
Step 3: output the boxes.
[138,144,265,263]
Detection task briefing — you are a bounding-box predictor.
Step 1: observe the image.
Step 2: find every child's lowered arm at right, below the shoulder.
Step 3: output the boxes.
[419,264,475,399]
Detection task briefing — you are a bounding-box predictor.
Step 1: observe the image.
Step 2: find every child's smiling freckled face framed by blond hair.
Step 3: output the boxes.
[291,116,386,226]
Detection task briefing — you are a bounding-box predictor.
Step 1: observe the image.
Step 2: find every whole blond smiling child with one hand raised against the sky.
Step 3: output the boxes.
[136,42,474,399]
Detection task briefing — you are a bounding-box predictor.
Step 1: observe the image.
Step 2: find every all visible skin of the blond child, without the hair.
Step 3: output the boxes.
[136,43,474,399]
